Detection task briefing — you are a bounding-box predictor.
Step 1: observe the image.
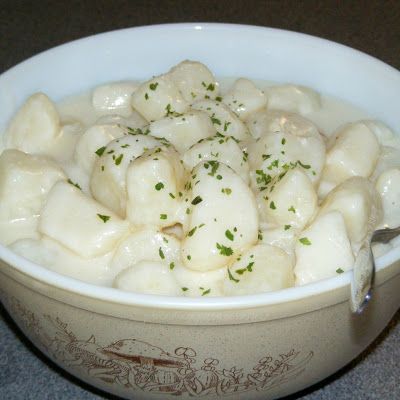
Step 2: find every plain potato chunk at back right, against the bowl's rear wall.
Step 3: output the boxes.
[266,84,321,115]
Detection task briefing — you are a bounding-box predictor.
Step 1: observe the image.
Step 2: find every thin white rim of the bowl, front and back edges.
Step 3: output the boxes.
[0,22,400,311]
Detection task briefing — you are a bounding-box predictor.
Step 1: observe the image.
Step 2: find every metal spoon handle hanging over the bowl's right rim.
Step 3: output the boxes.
[350,227,400,314]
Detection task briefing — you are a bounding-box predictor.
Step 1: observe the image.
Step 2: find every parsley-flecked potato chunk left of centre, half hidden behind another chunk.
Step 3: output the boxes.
[90,134,160,218]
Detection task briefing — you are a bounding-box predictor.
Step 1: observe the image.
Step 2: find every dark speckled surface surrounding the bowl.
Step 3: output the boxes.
[0,0,400,400]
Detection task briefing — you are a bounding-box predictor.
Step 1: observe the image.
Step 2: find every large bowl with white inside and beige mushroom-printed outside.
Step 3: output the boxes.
[0,23,400,399]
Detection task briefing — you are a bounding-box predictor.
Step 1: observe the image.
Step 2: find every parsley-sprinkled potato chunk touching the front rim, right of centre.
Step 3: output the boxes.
[223,244,294,296]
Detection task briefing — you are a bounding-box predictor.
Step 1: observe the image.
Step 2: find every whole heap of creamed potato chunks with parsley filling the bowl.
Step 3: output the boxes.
[0,61,400,297]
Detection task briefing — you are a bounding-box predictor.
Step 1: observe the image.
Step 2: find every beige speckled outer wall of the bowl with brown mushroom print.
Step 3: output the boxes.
[0,261,400,400]
